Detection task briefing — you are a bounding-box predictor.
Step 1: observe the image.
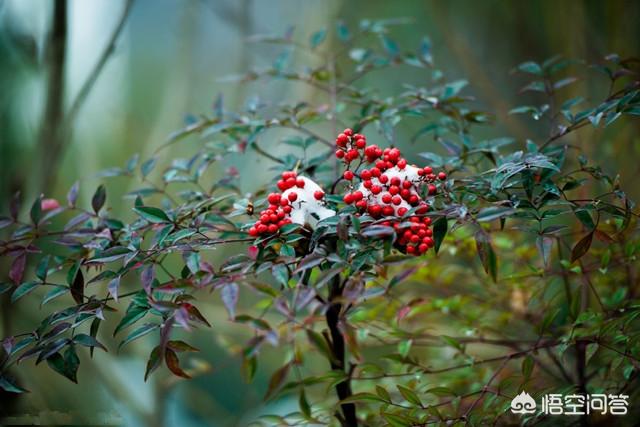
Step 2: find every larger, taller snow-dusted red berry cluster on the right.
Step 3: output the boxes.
[336,129,447,255]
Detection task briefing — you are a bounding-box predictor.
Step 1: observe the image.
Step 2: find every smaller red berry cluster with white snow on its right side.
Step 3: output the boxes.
[249,171,336,237]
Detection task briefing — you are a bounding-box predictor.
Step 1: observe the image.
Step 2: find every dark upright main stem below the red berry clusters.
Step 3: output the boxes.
[325,277,358,427]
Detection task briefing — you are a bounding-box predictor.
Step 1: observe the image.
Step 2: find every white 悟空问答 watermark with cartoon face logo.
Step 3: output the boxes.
[511,390,629,415]
